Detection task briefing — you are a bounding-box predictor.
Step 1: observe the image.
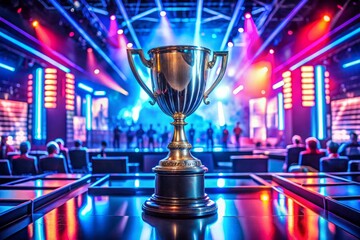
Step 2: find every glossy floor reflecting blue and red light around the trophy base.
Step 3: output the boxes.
[0,172,360,239]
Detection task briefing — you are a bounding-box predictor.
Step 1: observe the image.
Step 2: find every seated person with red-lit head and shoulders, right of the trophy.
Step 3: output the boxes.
[299,137,325,171]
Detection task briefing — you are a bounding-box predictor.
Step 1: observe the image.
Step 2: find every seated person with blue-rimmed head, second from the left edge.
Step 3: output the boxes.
[12,141,38,175]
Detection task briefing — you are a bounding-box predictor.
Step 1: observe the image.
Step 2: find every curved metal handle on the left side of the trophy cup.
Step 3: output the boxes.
[126,49,156,105]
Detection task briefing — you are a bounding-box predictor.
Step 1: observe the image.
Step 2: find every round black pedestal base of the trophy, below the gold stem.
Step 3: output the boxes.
[142,166,217,218]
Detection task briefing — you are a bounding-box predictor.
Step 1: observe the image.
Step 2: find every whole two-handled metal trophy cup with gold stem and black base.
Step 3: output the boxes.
[127,46,228,218]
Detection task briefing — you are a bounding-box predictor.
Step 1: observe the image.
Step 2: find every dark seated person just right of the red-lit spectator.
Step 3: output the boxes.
[320,141,349,172]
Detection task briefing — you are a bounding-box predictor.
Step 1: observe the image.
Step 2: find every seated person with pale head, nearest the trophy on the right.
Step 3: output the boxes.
[283,135,306,172]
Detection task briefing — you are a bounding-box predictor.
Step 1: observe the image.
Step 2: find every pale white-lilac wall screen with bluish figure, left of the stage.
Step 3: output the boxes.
[92,98,109,130]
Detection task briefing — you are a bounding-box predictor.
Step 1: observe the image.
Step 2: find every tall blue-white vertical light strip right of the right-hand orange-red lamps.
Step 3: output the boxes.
[315,65,326,140]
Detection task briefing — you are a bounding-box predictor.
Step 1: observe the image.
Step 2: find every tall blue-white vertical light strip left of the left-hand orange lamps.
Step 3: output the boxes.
[34,68,44,140]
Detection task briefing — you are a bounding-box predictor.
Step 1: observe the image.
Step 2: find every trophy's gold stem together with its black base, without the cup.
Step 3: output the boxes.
[143,113,217,218]
